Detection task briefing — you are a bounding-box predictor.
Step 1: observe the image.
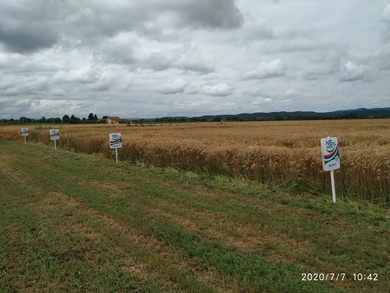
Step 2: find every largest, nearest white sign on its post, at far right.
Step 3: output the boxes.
[321,136,340,202]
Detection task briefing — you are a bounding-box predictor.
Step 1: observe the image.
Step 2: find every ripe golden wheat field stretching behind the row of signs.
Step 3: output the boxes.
[0,119,390,205]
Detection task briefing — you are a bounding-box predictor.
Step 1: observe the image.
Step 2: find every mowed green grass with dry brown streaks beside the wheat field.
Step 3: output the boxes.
[0,142,390,292]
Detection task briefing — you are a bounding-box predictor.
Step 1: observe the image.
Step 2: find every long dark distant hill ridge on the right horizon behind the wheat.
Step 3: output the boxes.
[192,107,390,121]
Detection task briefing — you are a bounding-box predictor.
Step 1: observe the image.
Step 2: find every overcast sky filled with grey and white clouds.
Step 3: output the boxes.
[0,0,390,119]
